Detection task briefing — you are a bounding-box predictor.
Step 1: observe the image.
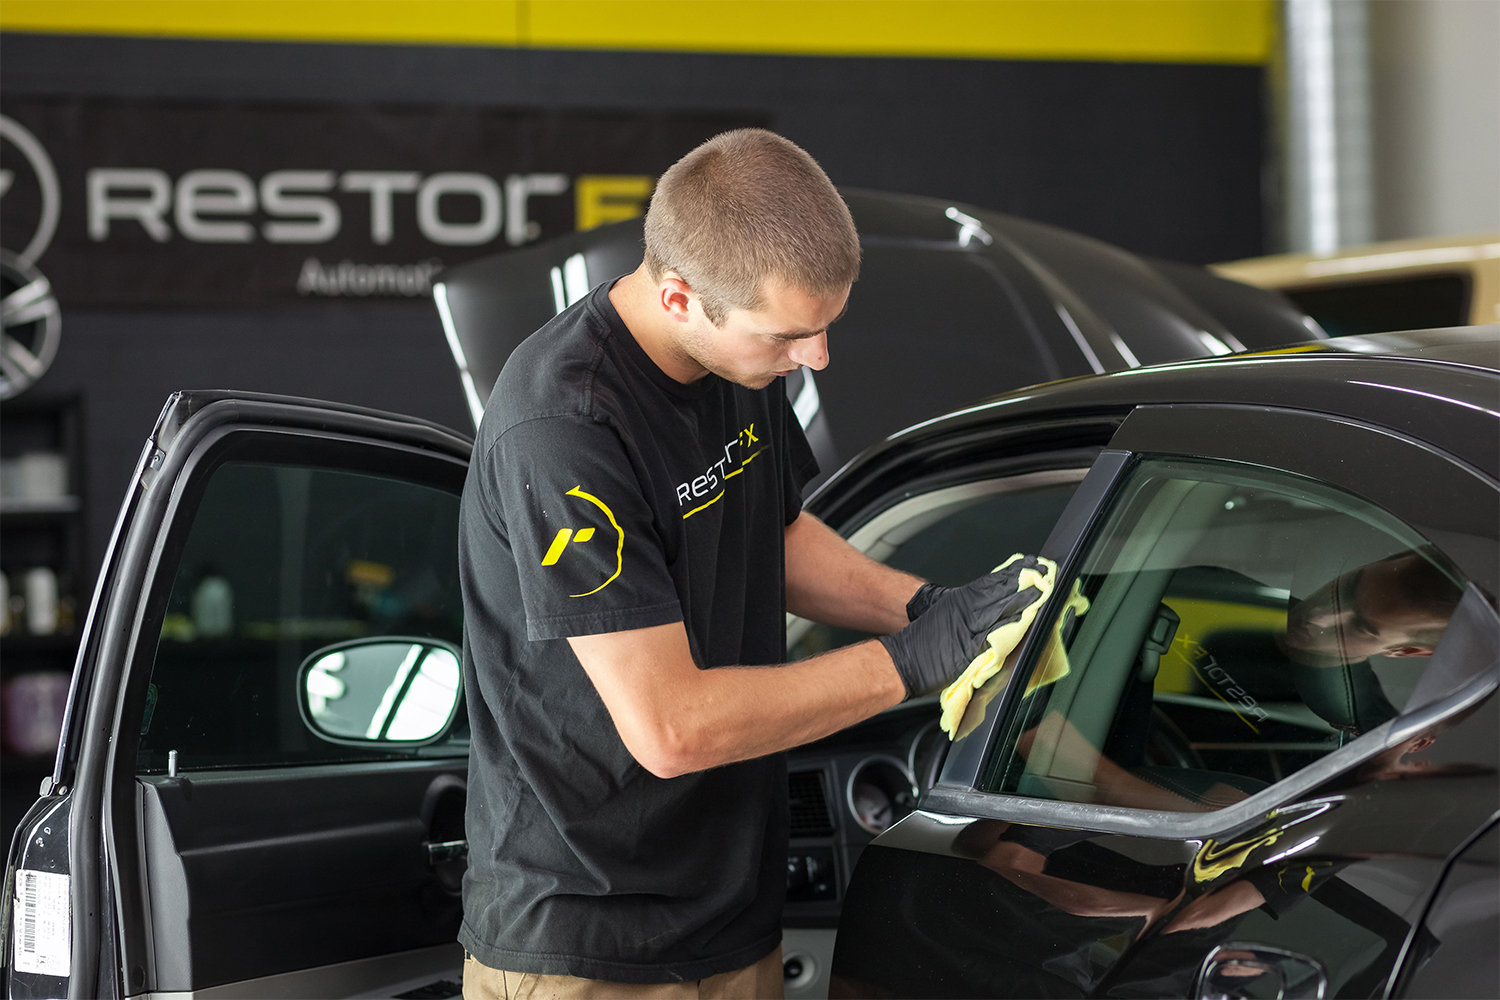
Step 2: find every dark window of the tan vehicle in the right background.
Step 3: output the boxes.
[1287,274,1469,337]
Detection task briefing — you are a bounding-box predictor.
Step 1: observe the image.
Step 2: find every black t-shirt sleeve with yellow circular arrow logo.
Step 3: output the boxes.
[488,417,683,640]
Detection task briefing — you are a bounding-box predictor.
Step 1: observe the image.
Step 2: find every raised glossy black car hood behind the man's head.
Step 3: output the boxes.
[434,189,1325,486]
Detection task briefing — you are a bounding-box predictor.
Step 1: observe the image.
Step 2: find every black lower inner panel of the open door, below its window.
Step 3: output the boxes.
[138,760,467,993]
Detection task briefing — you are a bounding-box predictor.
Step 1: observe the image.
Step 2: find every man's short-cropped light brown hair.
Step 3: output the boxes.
[645,129,860,327]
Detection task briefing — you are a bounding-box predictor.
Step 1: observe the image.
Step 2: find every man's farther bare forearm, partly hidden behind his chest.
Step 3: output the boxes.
[786,511,923,636]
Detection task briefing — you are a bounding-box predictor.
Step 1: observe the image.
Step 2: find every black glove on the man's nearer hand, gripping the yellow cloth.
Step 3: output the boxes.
[881,556,1044,699]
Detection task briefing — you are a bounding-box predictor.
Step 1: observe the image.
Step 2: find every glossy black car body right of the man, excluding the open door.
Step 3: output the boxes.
[803,327,1500,997]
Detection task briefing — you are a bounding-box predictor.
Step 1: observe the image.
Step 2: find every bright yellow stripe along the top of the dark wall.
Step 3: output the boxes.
[0,0,1275,63]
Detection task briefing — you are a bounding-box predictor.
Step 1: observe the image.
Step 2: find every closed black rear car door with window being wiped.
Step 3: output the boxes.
[831,406,1500,997]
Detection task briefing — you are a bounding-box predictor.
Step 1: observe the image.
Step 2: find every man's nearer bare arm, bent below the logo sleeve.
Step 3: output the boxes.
[569,626,906,778]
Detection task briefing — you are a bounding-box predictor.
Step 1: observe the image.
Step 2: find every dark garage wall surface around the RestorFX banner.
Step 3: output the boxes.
[0,15,1268,581]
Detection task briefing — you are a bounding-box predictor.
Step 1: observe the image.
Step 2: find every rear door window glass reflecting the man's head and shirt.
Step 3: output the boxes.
[960,459,1466,811]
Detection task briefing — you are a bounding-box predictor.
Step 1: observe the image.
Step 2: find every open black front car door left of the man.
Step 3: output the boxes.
[6,393,471,997]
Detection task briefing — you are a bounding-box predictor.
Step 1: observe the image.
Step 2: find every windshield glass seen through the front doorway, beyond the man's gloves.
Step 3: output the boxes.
[789,478,1077,660]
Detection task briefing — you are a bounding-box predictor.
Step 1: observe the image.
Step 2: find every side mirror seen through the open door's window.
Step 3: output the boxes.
[297,636,464,747]
